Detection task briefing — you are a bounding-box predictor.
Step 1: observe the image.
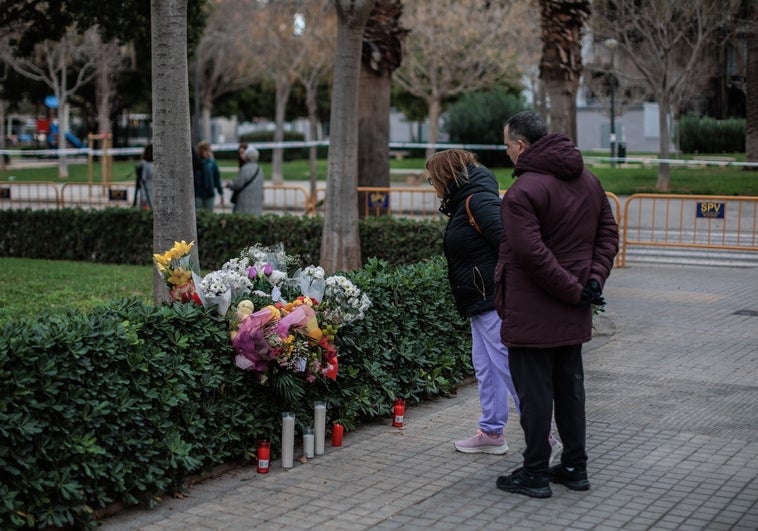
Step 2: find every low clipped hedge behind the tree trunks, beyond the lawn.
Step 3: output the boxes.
[0,208,445,270]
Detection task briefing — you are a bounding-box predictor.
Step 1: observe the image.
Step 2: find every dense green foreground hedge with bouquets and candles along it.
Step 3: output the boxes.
[0,257,472,529]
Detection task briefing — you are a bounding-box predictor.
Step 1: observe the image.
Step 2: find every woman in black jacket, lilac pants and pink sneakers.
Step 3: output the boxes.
[426,149,518,454]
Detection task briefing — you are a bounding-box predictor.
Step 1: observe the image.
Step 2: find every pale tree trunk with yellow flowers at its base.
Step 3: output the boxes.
[150,0,200,303]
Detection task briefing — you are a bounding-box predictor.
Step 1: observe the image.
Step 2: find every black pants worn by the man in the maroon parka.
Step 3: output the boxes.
[508,345,587,474]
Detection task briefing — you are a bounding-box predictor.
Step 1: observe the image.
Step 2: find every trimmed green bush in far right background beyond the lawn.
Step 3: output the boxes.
[678,113,745,153]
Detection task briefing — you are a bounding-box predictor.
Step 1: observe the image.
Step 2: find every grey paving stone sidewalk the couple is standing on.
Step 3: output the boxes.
[102,265,758,531]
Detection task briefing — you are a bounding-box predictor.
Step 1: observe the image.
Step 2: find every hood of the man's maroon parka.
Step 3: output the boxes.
[514,133,584,181]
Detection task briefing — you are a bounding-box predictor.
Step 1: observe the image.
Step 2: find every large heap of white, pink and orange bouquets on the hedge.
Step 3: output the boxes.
[200,246,371,382]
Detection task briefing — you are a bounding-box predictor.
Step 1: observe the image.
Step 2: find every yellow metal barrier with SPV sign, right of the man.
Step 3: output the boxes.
[620,194,758,267]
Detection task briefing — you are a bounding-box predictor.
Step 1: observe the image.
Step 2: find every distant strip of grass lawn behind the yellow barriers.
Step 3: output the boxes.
[0,153,758,196]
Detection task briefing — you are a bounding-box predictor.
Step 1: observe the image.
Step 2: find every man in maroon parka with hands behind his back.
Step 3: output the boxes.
[495,112,619,498]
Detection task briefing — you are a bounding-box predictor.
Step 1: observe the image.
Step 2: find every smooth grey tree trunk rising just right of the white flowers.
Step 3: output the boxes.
[320,0,374,273]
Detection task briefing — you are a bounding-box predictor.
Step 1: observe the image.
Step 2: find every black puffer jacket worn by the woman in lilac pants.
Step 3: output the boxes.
[440,165,502,317]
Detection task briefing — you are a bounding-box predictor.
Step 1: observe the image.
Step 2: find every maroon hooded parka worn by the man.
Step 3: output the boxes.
[495,133,619,348]
